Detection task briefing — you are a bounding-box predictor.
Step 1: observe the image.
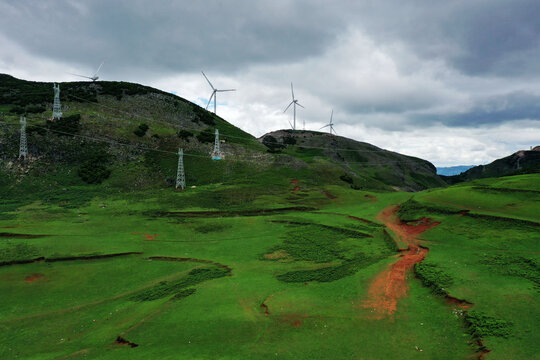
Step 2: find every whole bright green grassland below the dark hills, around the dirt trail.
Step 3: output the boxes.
[0,175,540,359]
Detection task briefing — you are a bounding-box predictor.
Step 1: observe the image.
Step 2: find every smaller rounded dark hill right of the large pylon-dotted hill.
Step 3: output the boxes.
[259,130,446,191]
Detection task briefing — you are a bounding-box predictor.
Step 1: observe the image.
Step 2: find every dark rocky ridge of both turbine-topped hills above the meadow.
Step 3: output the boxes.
[0,74,445,197]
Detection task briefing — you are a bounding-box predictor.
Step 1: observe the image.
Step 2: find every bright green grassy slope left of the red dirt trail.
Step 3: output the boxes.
[0,183,480,359]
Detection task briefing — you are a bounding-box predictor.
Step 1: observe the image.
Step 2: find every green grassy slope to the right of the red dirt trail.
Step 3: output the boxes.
[396,175,540,359]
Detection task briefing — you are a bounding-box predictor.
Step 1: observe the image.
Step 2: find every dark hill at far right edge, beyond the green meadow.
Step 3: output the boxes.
[441,146,540,184]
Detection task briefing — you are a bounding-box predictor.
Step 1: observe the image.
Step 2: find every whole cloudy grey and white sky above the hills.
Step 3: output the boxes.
[0,0,540,166]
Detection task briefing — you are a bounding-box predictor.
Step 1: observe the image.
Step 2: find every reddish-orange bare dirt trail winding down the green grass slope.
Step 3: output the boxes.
[360,206,439,318]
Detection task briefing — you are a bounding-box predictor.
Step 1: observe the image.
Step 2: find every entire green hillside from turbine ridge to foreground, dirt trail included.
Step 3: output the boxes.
[0,76,540,360]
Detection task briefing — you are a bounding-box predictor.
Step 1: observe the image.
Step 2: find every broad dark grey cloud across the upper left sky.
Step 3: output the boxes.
[0,0,343,72]
